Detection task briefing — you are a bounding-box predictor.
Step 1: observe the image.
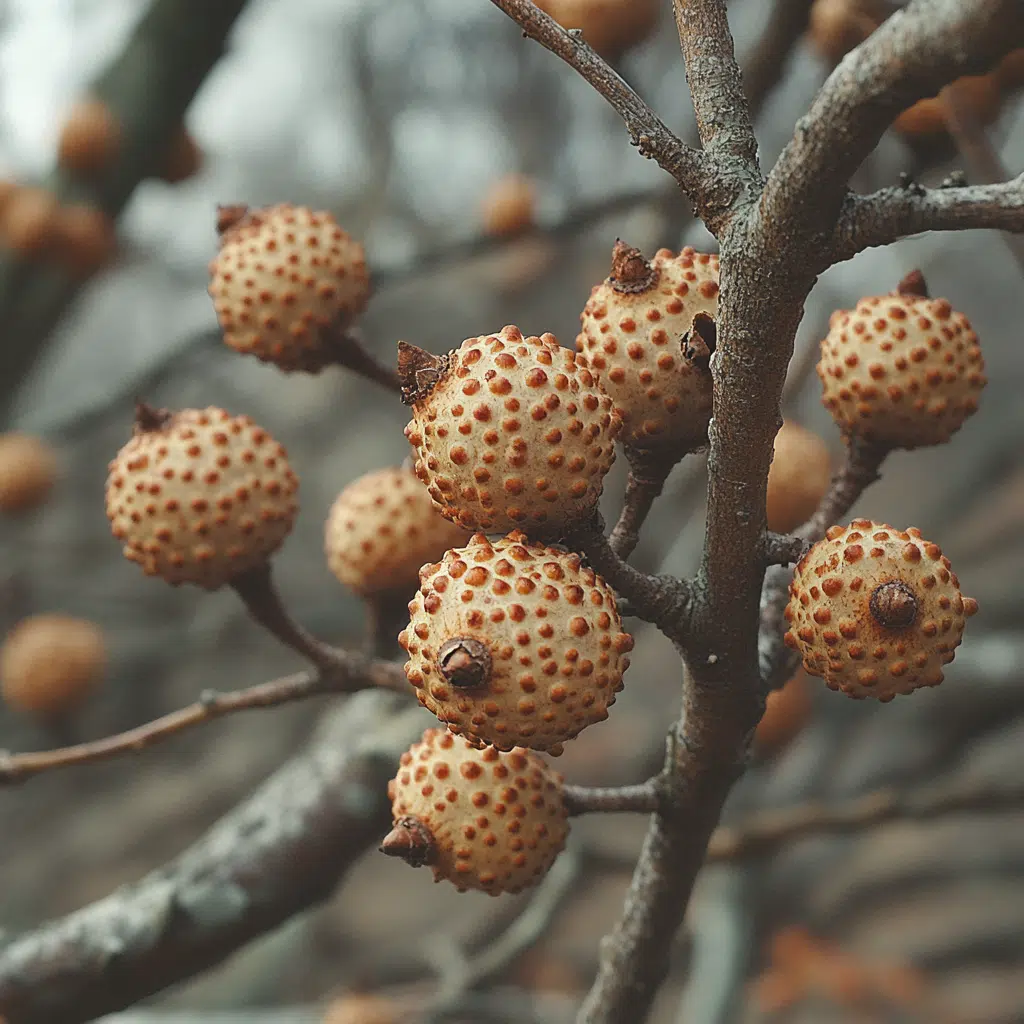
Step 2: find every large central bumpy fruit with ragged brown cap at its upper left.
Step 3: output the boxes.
[398,327,621,532]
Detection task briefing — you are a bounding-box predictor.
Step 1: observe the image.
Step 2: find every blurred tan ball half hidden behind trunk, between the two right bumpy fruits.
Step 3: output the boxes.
[768,420,831,534]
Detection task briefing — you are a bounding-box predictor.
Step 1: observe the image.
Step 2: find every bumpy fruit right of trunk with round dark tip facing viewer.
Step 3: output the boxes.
[785,519,978,701]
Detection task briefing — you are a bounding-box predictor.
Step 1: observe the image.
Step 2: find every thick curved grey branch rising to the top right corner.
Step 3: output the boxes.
[761,0,1024,253]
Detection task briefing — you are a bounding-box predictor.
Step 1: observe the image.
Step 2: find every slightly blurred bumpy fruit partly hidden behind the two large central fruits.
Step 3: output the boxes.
[325,467,468,598]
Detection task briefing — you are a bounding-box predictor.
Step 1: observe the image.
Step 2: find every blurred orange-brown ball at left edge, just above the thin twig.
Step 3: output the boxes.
[0,614,106,718]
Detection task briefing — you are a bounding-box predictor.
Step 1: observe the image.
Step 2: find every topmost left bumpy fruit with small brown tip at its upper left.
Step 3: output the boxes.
[209,203,370,373]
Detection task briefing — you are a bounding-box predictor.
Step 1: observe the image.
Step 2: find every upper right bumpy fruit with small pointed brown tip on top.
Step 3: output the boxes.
[817,271,986,449]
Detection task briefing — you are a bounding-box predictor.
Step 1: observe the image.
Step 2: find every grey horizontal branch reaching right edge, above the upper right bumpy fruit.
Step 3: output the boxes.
[833,174,1024,261]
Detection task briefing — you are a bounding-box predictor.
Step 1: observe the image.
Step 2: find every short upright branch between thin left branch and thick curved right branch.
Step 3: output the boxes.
[672,0,762,182]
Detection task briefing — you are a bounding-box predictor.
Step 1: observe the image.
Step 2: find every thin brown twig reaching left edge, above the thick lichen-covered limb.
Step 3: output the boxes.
[0,651,410,785]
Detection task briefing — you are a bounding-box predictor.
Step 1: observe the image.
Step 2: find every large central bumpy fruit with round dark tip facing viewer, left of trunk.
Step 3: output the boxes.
[398,531,633,754]
